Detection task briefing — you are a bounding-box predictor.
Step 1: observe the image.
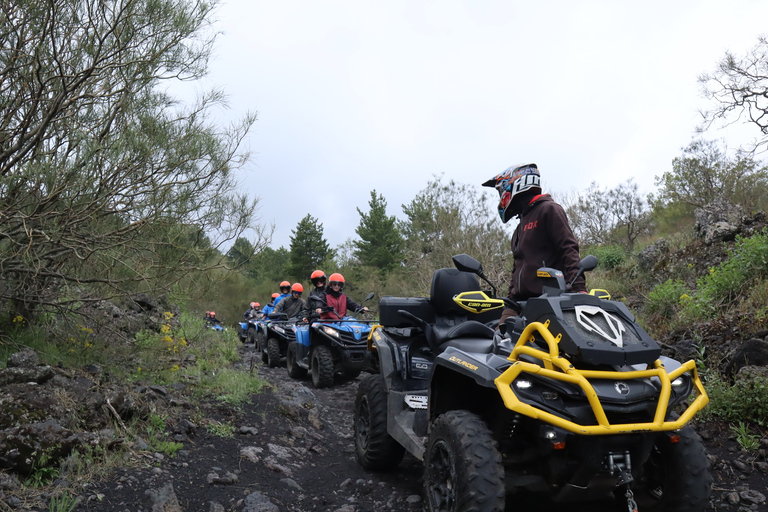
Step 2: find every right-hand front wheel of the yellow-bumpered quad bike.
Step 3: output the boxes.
[632,425,712,512]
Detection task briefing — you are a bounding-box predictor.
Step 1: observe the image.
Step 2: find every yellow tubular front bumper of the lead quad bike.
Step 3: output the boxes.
[494,322,709,435]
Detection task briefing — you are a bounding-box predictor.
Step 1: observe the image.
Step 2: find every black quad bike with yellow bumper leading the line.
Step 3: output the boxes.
[354,255,712,512]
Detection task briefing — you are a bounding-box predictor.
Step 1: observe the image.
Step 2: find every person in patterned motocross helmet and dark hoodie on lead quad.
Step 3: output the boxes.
[483,164,586,325]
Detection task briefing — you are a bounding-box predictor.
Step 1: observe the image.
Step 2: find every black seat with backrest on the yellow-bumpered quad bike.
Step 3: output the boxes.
[424,268,494,354]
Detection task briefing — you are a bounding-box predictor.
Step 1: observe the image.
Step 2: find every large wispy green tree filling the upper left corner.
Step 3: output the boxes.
[0,0,264,314]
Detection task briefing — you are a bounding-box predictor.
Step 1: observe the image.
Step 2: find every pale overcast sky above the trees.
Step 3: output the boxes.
[201,0,768,248]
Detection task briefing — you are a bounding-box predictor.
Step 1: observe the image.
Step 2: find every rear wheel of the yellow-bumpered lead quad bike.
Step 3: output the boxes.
[354,374,405,469]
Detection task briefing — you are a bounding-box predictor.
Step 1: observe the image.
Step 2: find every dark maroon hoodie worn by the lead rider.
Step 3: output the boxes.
[508,194,586,300]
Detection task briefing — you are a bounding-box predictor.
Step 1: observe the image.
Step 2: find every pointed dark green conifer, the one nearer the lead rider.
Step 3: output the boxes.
[354,190,405,273]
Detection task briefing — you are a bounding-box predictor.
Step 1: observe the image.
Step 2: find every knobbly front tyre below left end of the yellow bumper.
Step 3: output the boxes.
[424,410,505,512]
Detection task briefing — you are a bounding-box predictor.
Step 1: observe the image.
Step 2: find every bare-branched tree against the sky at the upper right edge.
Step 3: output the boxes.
[699,36,768,150]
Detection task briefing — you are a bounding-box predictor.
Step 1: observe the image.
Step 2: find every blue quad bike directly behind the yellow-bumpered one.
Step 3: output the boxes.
[286,293,373,388]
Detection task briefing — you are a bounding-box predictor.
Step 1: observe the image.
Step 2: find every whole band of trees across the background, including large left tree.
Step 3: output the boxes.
[0,0,768,336]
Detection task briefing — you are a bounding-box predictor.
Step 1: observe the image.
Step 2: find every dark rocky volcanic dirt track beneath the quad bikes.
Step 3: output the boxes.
[0,345,768,512]
